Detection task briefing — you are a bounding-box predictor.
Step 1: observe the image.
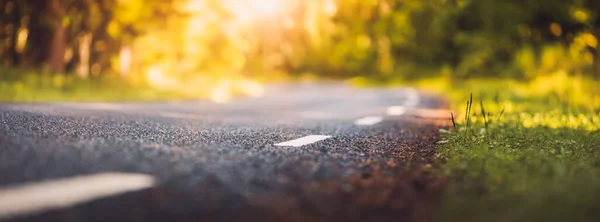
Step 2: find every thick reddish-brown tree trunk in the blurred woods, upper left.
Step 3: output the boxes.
[46,0,66,72]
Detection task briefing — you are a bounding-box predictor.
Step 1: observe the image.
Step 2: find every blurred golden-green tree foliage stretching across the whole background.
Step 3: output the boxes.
[0,0,600,80]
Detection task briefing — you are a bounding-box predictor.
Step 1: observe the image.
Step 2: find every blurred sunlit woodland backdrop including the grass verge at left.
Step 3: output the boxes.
[0,0,600,103]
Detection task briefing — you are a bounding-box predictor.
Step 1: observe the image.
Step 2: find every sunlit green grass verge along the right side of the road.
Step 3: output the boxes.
[418,74,600,221]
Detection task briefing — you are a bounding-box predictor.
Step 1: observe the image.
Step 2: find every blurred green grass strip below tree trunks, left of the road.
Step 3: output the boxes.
[0,67,202,102]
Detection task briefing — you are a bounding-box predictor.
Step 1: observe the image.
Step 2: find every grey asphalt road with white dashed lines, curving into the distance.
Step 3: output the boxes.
[0,83,450,221]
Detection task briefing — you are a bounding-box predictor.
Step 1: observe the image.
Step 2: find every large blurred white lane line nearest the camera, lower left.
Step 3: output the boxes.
[0,173,156,220]
